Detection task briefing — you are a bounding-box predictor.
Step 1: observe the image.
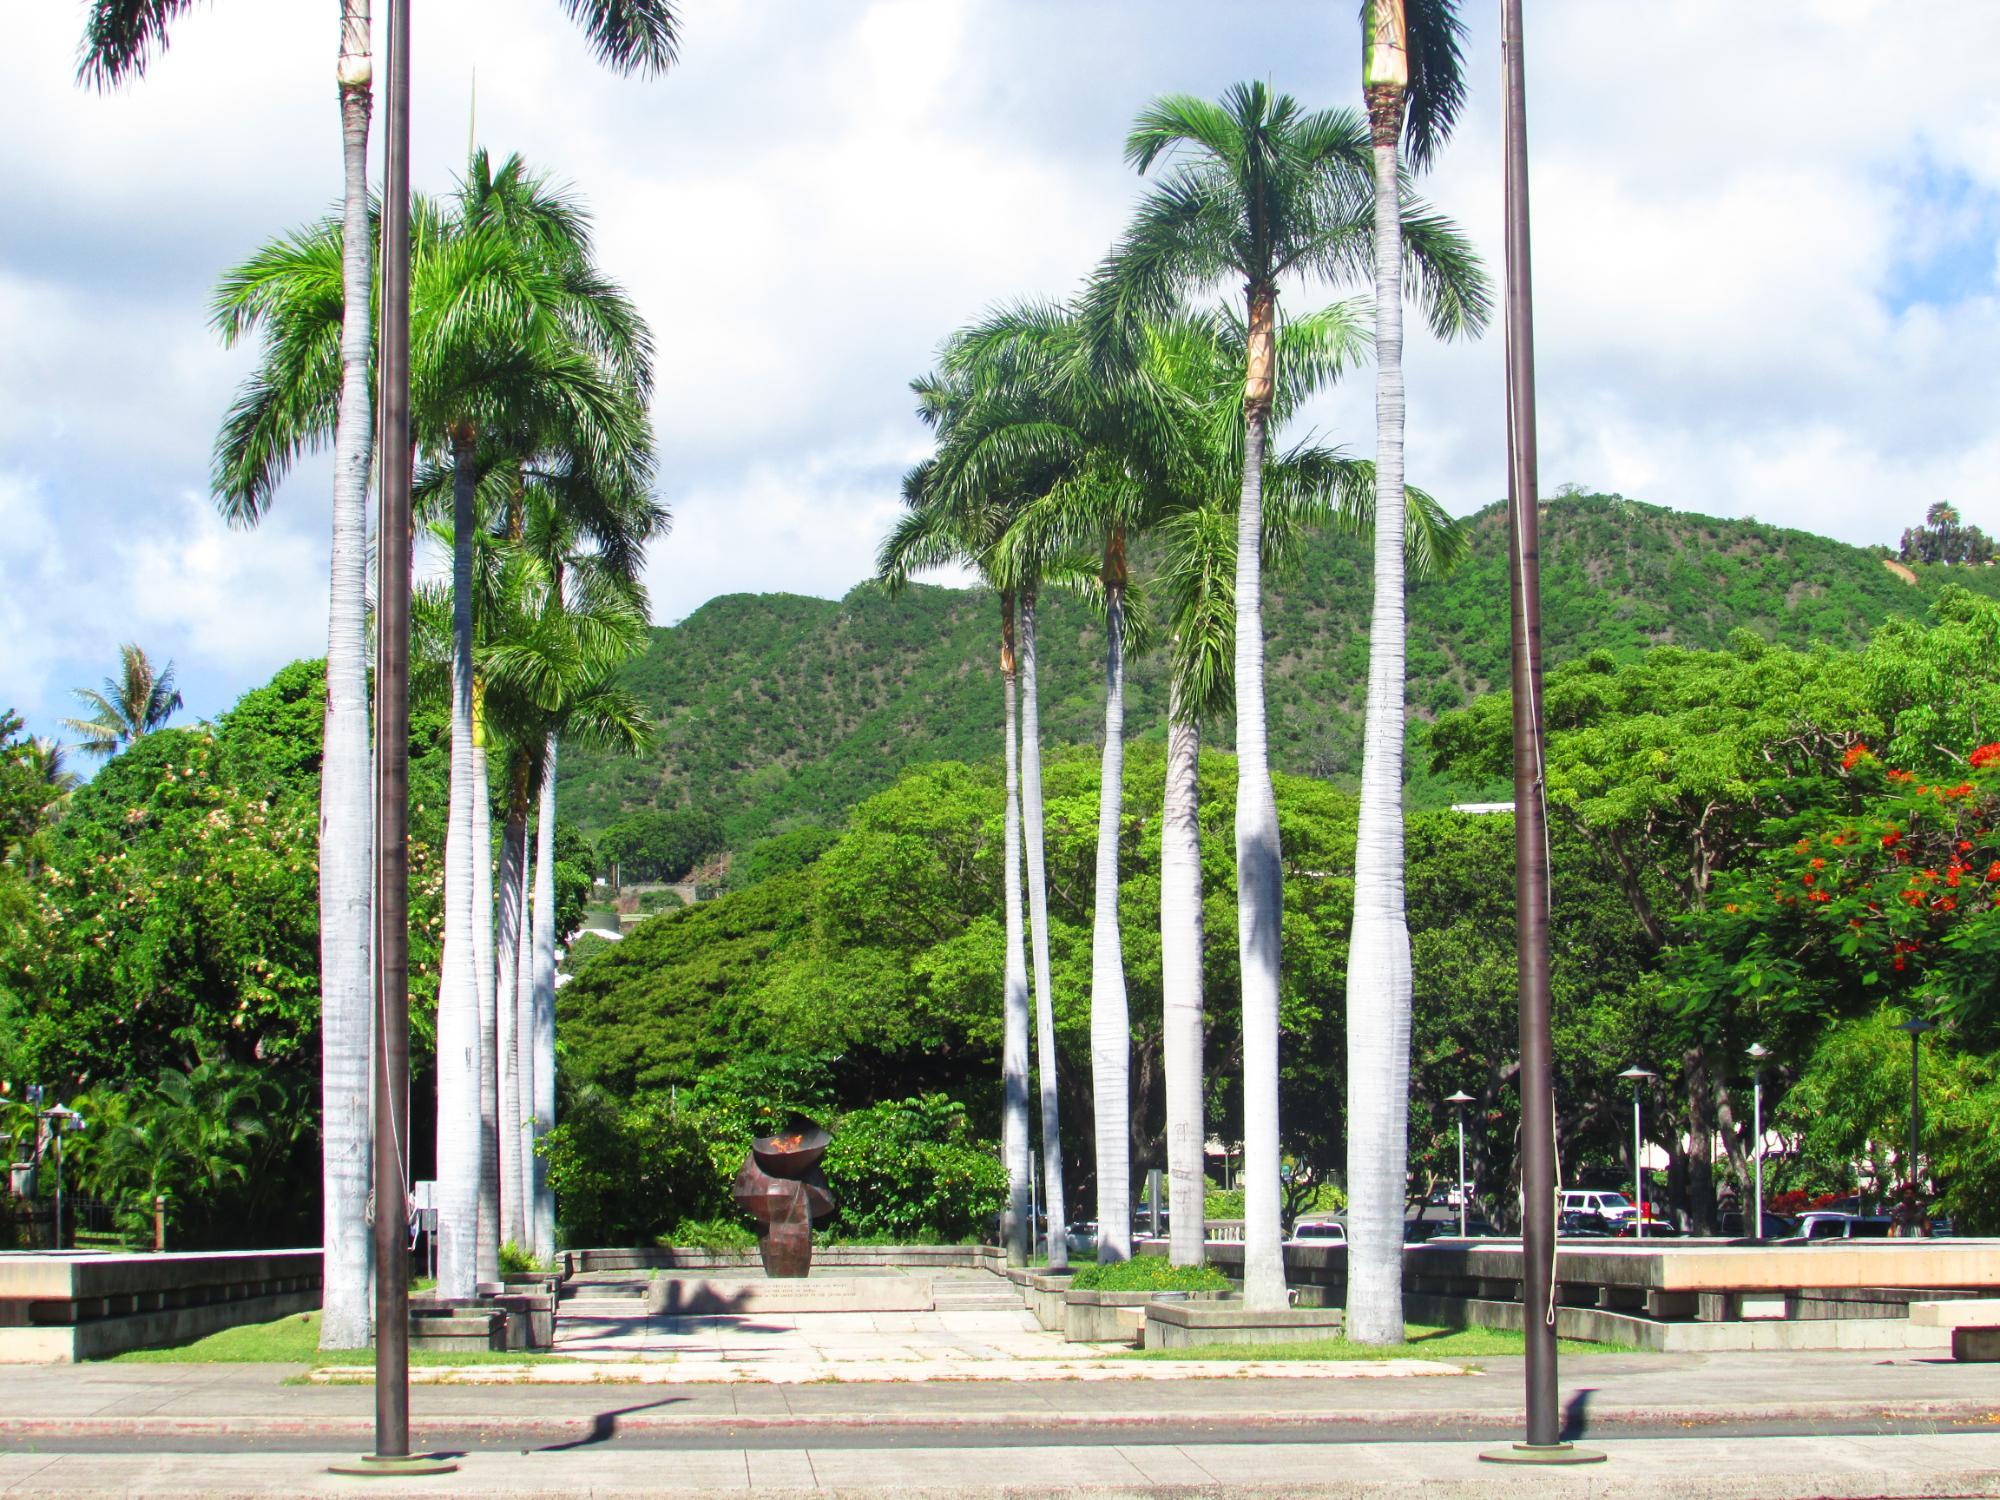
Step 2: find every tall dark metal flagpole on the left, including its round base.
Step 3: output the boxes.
[334,0,458,1476]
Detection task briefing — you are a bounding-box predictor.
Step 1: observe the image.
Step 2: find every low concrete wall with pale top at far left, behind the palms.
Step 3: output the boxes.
[0,1250,322,1364]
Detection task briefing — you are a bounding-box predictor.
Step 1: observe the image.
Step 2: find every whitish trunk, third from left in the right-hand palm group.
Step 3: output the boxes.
[1090,526,1132,1262]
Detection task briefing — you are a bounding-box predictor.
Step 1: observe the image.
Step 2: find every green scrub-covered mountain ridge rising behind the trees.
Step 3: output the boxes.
[562,494,2000,848]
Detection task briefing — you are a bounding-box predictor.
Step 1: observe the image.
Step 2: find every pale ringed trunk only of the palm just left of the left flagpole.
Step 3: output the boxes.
[320,0,374,1348]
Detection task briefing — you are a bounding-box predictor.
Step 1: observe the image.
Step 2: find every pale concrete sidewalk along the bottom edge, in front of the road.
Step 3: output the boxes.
[0,1434,2000,1500]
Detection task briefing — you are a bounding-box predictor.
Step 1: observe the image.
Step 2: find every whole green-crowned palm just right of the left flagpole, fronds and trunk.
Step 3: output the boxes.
[216,158,646,1296]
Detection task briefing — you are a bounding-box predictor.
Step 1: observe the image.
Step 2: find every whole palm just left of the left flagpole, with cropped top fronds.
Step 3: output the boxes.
[78,0,676,1348]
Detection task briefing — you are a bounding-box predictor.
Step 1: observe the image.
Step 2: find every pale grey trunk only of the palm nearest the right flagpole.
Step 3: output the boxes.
[1348,86,1410,1344]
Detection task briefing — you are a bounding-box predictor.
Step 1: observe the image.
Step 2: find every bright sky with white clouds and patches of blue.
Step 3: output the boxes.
[0,0,2000,748]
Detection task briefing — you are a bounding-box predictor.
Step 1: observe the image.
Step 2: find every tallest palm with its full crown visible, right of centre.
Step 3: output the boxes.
[1084,84,1488,1306]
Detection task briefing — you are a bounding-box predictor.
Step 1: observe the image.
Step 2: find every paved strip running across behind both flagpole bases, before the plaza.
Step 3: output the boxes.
[0,1352,2000,1448]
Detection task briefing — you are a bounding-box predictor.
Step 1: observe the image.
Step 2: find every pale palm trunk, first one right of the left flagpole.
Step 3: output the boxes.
[438,426,480,1296]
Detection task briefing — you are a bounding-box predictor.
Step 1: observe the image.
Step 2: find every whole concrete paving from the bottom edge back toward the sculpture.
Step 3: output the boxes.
[0,1272,2000,1500]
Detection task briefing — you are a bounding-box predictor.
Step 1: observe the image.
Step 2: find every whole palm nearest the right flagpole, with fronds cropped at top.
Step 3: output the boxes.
[1348,0,1464,1344]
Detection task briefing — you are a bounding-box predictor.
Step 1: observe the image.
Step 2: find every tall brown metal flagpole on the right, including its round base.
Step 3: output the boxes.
[1480,0,1604,1464]
